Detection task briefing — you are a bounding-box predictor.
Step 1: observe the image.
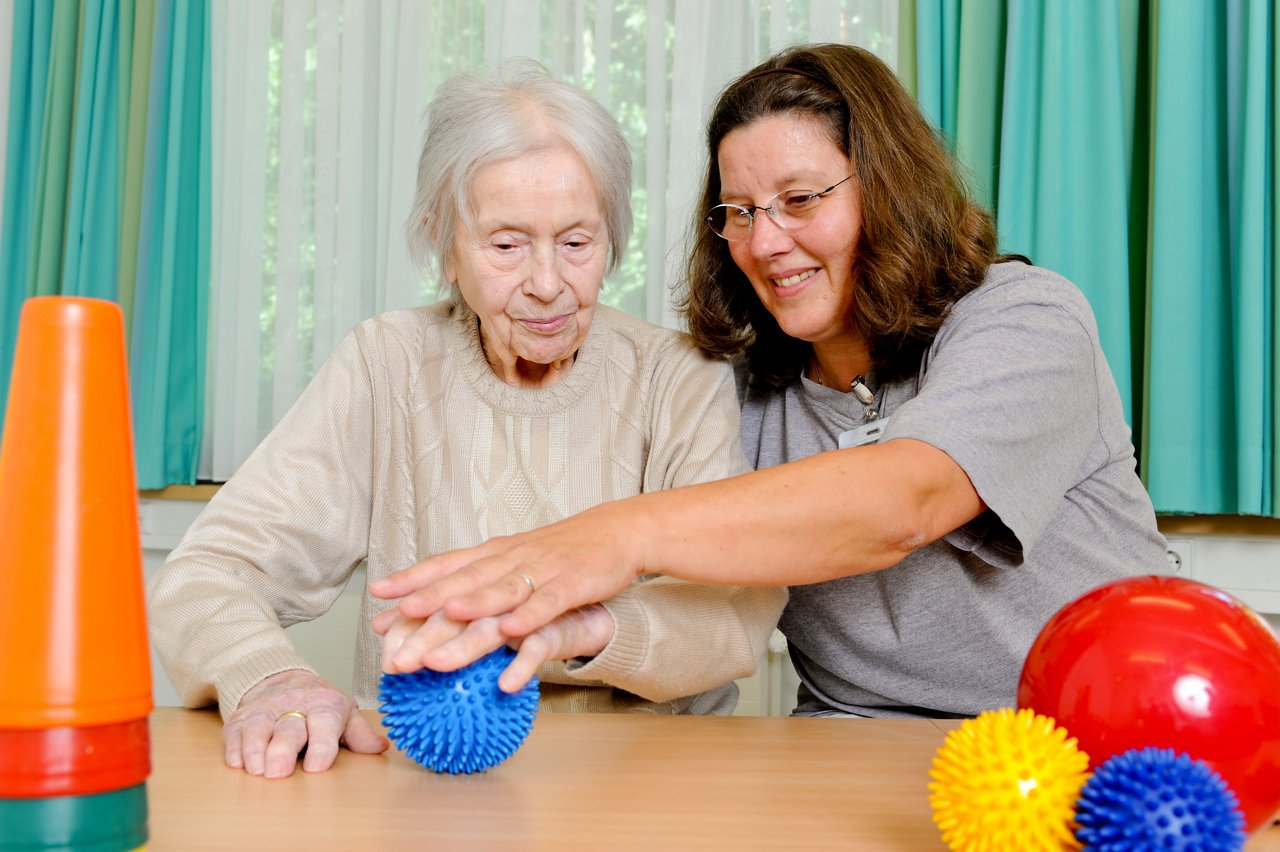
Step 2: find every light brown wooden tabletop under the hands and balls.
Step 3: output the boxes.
[147,707,1280,852]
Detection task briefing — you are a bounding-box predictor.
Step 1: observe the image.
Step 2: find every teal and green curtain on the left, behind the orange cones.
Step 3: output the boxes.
[0,0,210,487]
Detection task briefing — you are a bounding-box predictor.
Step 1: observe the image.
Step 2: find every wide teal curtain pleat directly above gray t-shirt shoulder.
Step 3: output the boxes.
[998,0,1133,422]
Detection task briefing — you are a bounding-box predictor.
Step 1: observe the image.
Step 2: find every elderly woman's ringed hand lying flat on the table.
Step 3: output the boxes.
[223,669,389,778]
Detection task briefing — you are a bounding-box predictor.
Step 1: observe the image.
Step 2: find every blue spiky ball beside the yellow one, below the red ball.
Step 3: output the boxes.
[1075,747,1245,852]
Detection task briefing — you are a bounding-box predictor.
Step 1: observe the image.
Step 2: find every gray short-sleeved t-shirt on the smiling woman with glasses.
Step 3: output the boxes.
[739,264,1167,716]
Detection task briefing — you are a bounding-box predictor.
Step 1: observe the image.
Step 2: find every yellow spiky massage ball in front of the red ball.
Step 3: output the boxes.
[929,707,1089,852]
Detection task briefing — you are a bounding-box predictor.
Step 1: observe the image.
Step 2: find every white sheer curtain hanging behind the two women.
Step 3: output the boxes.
[202,0,899,481]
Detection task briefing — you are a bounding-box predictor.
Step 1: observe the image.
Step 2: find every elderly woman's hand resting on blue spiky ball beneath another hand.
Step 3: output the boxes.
[374,604,613,692]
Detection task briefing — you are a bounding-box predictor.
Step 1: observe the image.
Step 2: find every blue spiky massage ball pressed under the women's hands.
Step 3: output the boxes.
[379,647,538,775]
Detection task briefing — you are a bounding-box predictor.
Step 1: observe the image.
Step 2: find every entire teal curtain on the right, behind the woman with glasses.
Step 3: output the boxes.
[914,0,1280,516]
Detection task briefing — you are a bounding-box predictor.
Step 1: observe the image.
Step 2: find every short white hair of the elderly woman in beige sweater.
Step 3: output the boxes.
[404,59,631,284]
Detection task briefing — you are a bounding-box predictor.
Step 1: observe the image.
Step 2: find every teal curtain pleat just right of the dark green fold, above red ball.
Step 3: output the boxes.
[1144,3,1238,512]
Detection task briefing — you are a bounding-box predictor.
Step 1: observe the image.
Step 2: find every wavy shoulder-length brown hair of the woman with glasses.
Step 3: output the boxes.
[680,45,997,388]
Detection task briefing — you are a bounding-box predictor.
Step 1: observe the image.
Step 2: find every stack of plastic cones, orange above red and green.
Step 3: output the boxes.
[0,297,152,852]
